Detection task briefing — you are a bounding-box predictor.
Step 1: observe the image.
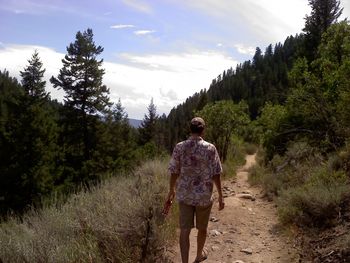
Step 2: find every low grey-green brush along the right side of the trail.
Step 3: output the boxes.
[249,143,350,227]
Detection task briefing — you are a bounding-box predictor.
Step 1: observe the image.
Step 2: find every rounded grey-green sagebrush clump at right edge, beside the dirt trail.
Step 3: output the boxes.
[277,168,350,227]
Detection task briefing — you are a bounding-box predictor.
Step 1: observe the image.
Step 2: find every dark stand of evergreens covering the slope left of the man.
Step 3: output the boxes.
[0,29,162,217]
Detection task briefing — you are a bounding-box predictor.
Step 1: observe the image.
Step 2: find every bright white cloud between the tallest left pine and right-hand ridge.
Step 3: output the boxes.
[105,50,237,118]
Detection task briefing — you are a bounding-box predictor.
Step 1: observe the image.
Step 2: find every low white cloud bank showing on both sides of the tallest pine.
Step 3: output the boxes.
[0,45,237,119]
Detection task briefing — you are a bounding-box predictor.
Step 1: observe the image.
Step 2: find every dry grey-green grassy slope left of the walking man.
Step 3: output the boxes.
[0,161,176,263]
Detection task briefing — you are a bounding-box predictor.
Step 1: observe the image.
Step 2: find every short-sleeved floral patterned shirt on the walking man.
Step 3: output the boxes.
[169,136,222,206]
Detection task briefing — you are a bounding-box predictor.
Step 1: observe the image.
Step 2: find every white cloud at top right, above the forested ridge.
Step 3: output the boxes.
[173,0,309,44]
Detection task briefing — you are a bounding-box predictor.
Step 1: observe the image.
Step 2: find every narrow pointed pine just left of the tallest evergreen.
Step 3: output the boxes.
[16,51,59,210]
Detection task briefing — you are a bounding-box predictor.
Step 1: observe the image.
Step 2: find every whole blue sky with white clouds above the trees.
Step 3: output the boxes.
[0,0,350,119]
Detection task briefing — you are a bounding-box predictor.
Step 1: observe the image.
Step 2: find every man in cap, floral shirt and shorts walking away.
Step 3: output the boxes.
[168,117,225,263]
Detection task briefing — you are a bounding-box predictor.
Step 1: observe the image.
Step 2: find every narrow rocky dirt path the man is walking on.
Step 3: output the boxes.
[174,155,299,263]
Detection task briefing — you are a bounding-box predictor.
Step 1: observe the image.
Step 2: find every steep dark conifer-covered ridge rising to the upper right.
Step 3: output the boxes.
[163,0,342,153]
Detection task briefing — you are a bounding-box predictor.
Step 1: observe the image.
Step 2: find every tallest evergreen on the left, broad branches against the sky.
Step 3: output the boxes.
[50,29,110,160]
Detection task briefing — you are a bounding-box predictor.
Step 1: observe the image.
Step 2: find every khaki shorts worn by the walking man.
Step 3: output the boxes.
[179,202,213,229]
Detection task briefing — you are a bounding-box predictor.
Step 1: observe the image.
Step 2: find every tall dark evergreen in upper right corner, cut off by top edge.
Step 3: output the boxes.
[303,0,343,62]
